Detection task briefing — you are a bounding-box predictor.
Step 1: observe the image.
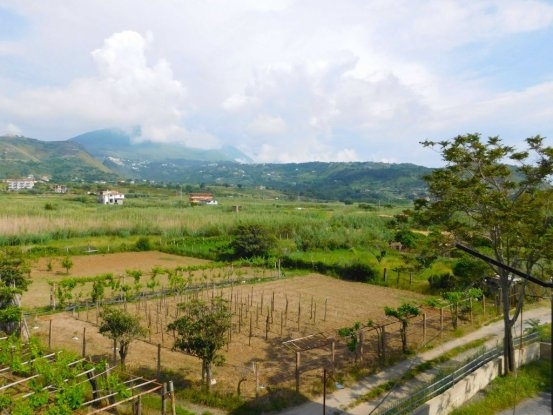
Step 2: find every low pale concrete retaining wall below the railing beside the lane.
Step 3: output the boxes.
[412,343,541,415]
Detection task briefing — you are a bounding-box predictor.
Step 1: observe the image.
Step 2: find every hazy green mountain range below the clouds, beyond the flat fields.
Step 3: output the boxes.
[0,130,431,202]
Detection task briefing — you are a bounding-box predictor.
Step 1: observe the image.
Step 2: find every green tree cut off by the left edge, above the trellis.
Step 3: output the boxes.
[0,254,31,334]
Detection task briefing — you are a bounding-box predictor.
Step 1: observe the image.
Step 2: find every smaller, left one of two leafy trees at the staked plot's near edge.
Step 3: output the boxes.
[99,307,147,366]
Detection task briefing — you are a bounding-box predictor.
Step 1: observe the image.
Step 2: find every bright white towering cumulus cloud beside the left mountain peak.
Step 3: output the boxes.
[0,31,220,148]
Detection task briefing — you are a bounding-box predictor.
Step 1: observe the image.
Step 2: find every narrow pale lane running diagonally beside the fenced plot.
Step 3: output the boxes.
[280,308,551,415]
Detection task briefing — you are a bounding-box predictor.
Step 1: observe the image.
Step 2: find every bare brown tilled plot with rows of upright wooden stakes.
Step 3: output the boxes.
[24,254,438,396]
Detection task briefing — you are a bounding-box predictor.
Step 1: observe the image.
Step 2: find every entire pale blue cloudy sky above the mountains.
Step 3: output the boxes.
[0,0,553,166]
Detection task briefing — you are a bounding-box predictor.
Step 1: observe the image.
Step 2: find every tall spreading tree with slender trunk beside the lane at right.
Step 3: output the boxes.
[418,134,553,372]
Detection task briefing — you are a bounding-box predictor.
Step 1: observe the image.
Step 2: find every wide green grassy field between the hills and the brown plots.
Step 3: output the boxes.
[0,188,444,292]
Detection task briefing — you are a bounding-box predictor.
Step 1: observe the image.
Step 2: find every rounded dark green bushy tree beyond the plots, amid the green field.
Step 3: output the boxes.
[230,223,276,258]
